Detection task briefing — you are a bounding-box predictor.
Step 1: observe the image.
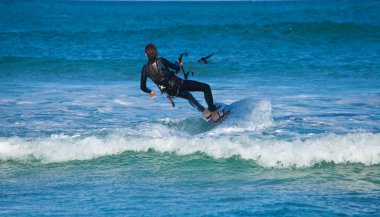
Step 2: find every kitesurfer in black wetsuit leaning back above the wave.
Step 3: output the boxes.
[140,44,227,122]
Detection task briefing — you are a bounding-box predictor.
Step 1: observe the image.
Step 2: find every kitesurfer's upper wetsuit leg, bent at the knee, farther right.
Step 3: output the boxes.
[179,80,216,112]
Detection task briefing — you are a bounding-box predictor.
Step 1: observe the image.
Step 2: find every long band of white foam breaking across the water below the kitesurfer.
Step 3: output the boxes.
[0,131,380,167]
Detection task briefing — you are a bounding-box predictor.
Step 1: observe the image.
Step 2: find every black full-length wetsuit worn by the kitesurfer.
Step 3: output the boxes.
[140,58,215,112]
